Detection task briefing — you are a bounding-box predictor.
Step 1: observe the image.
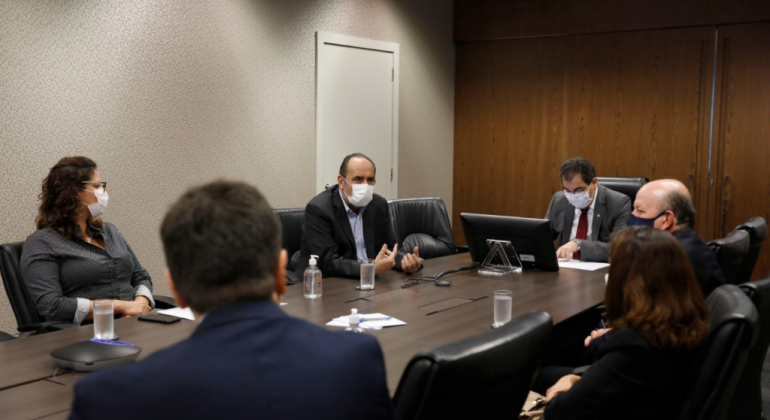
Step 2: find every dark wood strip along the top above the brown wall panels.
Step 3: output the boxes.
[454,0,770,41]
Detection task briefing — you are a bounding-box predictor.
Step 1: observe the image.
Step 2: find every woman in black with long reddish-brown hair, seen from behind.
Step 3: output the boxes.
[545,227,708,420]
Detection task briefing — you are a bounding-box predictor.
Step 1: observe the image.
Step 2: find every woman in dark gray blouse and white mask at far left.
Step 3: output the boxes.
[21,156,155,324]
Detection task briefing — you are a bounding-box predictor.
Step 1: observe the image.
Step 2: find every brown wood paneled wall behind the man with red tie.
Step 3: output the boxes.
[453,0,770,278]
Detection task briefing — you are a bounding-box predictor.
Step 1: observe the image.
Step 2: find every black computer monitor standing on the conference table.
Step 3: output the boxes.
[460,213,559,271]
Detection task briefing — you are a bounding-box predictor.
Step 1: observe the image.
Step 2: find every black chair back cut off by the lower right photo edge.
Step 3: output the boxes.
[728,278,770,420]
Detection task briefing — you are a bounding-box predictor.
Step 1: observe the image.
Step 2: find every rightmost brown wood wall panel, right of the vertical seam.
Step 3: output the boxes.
[709,23,770,279]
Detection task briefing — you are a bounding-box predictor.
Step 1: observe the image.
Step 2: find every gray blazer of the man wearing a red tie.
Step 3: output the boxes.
[545,184,631,262]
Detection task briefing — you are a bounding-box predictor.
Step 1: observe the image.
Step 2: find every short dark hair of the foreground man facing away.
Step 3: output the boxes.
[160,180,281,313]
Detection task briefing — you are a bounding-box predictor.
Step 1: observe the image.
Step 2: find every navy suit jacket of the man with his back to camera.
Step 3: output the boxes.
[70,301,395,420]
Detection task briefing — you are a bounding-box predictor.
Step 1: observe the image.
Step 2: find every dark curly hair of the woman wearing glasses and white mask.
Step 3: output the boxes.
[35,156,102,238]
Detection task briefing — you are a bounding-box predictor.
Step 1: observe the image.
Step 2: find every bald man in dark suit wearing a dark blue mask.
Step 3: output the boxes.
[628,179,725,296]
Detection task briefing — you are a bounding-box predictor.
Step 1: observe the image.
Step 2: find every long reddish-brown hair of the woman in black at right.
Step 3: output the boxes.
[604,226,708,349]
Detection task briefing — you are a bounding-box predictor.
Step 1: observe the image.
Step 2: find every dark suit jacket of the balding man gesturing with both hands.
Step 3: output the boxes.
[295,185,410,279]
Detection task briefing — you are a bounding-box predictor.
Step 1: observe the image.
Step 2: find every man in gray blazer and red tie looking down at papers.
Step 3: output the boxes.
[545,157,631,262]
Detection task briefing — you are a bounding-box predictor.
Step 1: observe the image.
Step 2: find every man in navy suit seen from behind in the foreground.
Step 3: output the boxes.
[70,181,394,420]
